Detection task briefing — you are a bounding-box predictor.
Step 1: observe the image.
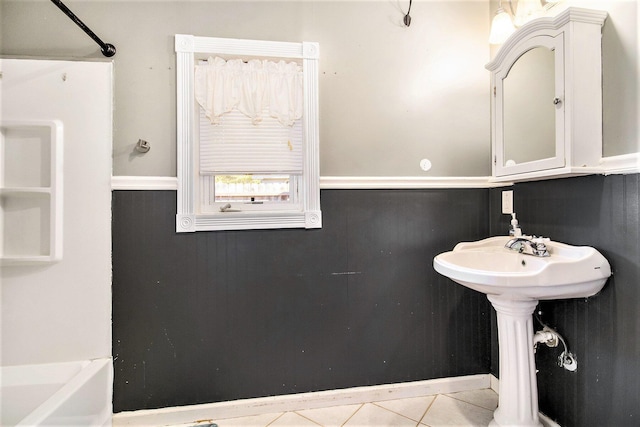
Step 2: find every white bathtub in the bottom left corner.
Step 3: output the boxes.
[0,358,113,427]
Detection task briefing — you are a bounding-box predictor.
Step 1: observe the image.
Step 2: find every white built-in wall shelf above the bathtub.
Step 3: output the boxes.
[0,120,63,264]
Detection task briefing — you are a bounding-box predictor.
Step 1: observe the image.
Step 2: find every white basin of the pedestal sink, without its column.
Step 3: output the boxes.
[433,236,611,300]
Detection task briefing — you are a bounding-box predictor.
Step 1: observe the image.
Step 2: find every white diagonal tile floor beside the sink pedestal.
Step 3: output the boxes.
[188,389,498,427]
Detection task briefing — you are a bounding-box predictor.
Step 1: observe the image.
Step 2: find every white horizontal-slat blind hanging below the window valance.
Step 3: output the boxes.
[199,107,303,175]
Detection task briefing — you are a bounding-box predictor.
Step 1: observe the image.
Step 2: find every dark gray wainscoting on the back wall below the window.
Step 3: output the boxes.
[113,189,491,412]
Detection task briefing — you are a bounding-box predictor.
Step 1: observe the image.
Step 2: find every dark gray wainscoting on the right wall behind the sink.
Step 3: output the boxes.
[490,174,640,427]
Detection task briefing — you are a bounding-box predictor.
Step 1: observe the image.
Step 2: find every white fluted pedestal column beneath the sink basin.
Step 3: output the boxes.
[487,295,542,427]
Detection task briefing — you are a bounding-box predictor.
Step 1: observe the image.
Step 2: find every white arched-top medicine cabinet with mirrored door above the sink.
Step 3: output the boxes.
[486,7,607,182]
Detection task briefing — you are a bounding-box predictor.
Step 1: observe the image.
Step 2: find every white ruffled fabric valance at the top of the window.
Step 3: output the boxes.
[195,57,304,126]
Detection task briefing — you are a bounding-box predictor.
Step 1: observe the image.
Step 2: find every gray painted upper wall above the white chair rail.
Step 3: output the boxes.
[0,0,640,176]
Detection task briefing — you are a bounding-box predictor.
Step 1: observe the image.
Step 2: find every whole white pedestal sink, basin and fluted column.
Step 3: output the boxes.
[433,236,611,426]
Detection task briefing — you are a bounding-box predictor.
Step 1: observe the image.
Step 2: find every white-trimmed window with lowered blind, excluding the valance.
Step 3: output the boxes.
[175,34,322,232]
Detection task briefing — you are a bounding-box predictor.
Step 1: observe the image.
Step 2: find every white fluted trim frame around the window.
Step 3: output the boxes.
[175,34,322,233]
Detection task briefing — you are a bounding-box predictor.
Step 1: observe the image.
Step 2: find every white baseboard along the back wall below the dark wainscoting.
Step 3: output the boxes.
[113,374,491,427]
